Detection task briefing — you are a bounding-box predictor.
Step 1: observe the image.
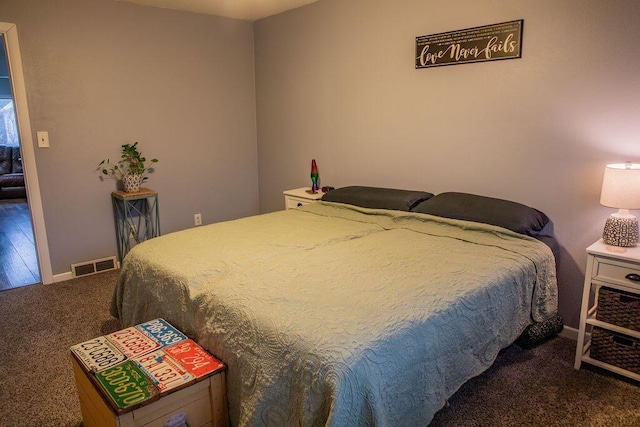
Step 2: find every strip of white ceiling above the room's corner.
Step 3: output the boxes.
[116,0,318,21]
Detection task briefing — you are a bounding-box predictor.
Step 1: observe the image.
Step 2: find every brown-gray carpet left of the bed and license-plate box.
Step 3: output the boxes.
[0,271,119,427]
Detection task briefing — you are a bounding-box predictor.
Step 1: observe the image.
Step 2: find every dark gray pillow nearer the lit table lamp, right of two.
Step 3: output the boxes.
[412,193,549,236]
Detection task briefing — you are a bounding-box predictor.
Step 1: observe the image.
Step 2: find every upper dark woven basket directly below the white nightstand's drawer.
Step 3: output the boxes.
[596,286,640,332]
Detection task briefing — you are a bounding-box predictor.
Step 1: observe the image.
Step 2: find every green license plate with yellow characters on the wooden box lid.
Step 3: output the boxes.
[96,360,159,412]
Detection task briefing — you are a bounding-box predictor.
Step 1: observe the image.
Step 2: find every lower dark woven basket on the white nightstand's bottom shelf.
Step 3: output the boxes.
[591,326,640,374]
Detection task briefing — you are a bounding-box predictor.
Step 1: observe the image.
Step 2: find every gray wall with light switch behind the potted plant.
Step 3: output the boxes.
[0,0,258,274]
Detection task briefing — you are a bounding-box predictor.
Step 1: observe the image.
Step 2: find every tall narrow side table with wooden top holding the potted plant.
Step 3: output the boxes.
[111,188,160,262]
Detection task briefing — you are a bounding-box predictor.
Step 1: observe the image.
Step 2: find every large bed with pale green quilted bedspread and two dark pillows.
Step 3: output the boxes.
[112,187,557,426]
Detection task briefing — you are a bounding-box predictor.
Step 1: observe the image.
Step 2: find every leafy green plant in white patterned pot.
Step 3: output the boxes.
[98,142,158,193]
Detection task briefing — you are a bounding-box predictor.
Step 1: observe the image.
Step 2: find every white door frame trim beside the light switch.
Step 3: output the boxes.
[0,22,53,285]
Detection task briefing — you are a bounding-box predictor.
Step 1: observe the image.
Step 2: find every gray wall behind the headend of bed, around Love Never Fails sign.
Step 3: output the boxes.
[254,0,640,327]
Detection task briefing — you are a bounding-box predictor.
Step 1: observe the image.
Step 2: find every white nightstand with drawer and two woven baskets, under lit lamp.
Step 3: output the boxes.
[574,240,640,381]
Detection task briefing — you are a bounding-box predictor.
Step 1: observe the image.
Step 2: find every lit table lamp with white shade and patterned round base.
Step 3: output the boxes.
[600,162,640,248]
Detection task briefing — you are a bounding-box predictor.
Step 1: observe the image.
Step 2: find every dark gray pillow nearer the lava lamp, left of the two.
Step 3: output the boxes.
[322,186,433,211]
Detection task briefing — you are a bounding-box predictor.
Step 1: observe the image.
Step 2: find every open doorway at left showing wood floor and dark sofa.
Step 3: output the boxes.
[0,34,40,290]
